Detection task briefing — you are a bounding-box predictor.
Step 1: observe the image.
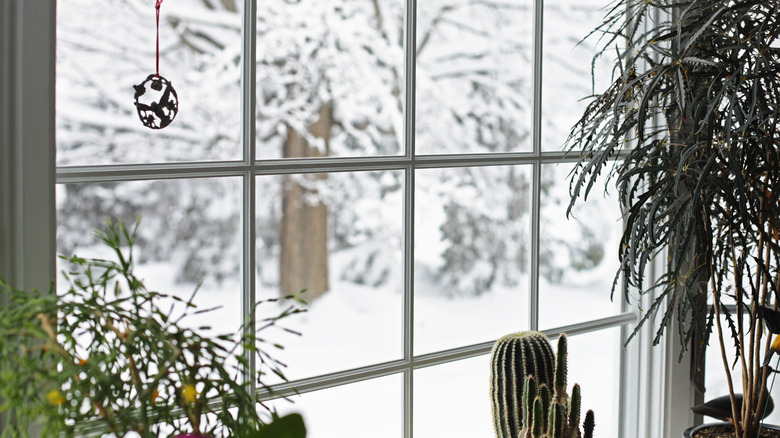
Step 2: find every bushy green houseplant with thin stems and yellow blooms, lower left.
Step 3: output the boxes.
[0,222,305,438]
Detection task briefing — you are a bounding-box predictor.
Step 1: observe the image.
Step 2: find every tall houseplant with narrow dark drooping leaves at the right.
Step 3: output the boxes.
[567,0,780,438]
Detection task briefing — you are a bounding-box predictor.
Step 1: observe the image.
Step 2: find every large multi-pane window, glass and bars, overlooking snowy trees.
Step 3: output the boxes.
[3,0,688,438]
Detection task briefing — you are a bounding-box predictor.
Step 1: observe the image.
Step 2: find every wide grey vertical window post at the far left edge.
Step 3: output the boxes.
[0,0,56,290]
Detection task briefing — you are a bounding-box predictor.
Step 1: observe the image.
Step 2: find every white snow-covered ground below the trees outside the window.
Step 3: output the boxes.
[58,236,620,438]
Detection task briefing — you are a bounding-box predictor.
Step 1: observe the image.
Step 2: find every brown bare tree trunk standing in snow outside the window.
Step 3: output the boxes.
[279,103,333,302]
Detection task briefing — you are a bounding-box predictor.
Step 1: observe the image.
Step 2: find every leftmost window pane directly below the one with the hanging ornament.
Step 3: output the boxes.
[57,178,242,334]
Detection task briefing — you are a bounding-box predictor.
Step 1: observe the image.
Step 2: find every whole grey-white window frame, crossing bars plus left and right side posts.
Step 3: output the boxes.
[0,0,693,438]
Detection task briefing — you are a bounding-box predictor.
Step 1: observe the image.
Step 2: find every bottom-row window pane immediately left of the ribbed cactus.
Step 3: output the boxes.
[414,355,493,438]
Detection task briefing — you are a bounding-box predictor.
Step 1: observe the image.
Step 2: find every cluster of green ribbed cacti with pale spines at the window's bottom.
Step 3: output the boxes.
[491,332,595,438]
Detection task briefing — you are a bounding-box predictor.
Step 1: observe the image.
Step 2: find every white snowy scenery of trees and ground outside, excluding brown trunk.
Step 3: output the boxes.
[57,0,632,438]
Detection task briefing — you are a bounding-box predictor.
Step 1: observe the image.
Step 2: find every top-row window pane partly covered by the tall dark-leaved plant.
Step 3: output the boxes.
[542,0,614,151]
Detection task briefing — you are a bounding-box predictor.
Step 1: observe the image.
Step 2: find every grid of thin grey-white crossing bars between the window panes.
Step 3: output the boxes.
[51,0,637,438]
